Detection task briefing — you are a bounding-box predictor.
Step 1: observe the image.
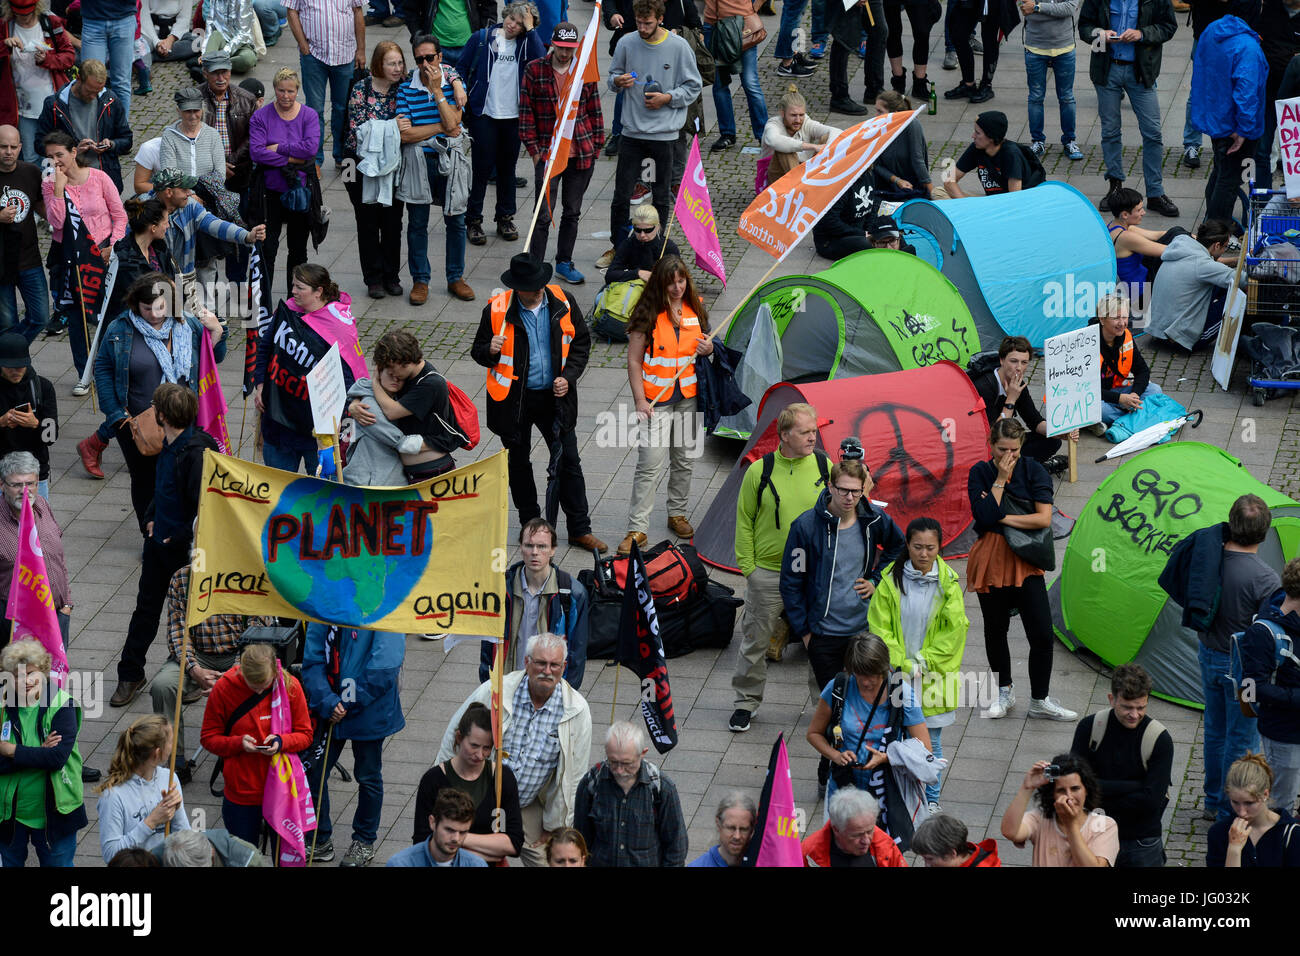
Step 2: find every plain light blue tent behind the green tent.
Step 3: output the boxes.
[894,181,1115,349]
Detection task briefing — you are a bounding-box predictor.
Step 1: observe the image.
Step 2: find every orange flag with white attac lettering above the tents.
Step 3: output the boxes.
[736,109,920,261]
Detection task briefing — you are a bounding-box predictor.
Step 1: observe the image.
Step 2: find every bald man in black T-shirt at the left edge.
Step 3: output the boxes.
[0,126,49,345]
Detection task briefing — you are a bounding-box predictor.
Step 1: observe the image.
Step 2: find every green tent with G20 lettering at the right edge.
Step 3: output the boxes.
[1049,441,1300,708]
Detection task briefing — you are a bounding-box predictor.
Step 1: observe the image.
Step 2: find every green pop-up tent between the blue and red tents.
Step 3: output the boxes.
[719,248,980,438]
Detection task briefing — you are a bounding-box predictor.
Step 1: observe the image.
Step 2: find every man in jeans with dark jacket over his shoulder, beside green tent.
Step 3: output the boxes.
[1160,494,1282,819]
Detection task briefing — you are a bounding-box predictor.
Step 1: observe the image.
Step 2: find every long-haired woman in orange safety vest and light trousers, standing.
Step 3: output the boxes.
[619,256,714,554]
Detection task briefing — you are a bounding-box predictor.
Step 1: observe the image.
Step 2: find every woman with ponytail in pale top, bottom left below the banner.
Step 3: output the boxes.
[98,714,190,864]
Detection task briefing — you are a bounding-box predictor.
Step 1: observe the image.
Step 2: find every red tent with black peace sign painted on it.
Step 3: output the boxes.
[694,362,988,571]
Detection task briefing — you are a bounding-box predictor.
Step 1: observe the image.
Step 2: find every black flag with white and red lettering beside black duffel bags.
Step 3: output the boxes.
[618,541,677,753]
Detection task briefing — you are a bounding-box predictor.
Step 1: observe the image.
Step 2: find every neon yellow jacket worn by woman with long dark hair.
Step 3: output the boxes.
[867,558,971,717]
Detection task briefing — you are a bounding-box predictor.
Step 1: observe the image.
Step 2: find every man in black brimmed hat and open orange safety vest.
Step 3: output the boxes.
[469,252,606,551]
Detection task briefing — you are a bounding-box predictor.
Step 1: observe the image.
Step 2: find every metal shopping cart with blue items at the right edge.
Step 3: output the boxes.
[1240,183,1300,406]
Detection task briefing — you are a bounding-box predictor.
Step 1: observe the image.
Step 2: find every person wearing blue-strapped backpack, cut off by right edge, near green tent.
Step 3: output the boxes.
[1234,558,1300,814]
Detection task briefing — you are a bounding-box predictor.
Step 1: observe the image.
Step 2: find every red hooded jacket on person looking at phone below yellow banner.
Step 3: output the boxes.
[199,665,312,806]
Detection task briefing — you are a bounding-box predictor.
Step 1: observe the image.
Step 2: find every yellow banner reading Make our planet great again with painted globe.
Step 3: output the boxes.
[189,451,508,637]
